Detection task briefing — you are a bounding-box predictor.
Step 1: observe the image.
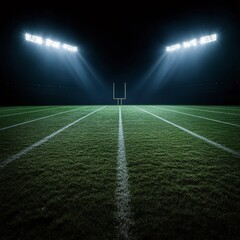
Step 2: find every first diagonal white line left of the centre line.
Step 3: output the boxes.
[0,107,105,167]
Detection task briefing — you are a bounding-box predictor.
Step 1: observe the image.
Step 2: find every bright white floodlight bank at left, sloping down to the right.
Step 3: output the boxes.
[25,33,78,52]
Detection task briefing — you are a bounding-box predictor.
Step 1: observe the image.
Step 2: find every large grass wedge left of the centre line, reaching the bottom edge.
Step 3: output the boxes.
[0,106,118,240]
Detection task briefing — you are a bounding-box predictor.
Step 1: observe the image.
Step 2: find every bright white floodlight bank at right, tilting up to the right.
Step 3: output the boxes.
[166,34,217,52]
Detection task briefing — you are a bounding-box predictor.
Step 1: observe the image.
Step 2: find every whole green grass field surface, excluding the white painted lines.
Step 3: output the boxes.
[0,105,240,240]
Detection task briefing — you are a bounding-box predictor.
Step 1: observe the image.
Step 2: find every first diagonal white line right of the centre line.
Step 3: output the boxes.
[135,106,240,158]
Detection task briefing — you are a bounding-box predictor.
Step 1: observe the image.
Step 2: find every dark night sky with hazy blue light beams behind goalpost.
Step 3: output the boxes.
[0,1,240,105]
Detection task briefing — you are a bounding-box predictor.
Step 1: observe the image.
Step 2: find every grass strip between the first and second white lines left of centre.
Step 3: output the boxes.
[0,106,102,162]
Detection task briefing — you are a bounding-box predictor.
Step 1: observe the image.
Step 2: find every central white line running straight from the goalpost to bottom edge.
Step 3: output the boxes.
[115,106,133,239]
